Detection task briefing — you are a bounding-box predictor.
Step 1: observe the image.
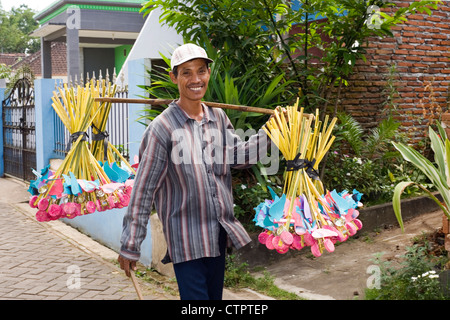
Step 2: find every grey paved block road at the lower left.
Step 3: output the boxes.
[0,203,149,300]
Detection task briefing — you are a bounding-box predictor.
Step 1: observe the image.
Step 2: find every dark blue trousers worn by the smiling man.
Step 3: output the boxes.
[173,226,227,300]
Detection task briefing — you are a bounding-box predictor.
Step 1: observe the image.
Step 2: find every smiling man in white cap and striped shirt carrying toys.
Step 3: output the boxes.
[118,44,268,300]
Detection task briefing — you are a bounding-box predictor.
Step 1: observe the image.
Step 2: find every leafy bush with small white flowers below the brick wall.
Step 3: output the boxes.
[323,113,429,205]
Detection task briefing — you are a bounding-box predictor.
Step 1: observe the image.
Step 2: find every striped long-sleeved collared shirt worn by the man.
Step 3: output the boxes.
[121,102,269,263]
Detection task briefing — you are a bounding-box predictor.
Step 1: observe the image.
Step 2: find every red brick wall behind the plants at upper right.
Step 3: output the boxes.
[341,0,450,141]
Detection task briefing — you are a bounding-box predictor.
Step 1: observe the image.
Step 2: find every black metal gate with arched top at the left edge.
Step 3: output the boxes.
[2,78,36,180]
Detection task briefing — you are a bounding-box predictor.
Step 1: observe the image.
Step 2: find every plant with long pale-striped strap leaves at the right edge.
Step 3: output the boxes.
[392,122,450,230]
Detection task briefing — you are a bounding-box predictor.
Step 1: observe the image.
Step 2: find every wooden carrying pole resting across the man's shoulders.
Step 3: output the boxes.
[94,97,274,115]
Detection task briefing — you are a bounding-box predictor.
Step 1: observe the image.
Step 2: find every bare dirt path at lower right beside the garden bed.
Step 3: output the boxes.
[255,211,442,300]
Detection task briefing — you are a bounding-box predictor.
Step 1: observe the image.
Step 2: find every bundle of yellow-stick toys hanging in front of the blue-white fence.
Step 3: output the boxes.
[28,80,136,221]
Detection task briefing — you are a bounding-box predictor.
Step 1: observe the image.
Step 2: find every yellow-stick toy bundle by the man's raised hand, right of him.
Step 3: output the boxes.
[253,102,362,257]
